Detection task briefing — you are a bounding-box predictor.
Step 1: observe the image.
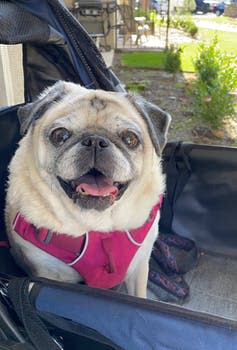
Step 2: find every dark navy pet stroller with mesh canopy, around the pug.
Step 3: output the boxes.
[0,0,237,350]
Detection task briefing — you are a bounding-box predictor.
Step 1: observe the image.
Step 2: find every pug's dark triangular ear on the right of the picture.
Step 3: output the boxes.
[126,94,171,156]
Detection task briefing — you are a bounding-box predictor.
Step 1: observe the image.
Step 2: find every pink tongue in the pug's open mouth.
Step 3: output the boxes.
[76,175,118,197]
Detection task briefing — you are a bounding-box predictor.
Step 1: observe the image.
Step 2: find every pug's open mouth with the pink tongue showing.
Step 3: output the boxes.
[58,168,128,210]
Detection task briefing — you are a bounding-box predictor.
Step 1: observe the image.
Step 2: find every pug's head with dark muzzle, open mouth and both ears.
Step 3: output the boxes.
[19,82,170,211]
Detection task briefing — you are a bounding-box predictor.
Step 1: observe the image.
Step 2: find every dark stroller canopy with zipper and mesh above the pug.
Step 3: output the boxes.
[0,0,121,102]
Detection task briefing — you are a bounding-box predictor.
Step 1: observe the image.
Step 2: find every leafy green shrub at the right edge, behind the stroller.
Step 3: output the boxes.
[192,38,237,129]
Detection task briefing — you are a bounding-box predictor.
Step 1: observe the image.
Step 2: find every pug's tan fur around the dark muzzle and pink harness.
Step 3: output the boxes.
[6,83,169,297]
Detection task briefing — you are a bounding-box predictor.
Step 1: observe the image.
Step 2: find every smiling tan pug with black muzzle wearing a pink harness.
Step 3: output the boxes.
[5,81,171,297]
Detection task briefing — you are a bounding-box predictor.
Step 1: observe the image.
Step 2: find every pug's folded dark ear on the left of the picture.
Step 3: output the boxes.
[18,81,66,135]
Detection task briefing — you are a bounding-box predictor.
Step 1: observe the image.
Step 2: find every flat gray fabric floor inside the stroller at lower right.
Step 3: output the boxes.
[184,252,237,321]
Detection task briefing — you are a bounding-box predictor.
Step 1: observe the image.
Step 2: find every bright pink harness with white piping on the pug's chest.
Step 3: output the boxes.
[13,197,162,288]
